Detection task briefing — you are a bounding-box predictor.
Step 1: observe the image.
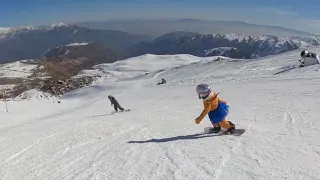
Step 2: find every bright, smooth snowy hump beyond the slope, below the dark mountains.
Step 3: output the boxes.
[80,54,222,82]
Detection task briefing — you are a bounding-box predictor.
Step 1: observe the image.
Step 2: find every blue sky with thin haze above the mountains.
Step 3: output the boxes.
[0,0,320,34]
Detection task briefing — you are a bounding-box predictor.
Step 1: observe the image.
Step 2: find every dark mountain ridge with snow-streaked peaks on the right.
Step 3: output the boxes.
[128,32,320,58]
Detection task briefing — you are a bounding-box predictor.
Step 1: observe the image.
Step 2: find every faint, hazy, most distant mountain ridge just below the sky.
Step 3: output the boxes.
[77,18,315,37]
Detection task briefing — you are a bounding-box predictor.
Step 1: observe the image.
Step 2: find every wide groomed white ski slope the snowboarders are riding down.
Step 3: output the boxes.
[0,48,320,180]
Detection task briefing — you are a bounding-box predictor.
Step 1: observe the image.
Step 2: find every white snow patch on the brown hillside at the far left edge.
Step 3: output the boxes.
[0,60,38,78]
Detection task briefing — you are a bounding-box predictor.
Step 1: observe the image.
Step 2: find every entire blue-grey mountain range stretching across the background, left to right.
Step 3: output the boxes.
[0,19,320,63]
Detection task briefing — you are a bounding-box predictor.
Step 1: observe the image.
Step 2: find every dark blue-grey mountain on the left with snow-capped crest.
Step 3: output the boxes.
[0,23,152,63]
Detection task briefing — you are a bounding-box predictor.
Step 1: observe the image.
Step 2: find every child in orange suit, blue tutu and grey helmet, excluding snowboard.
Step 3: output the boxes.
[195,84,235,134]
